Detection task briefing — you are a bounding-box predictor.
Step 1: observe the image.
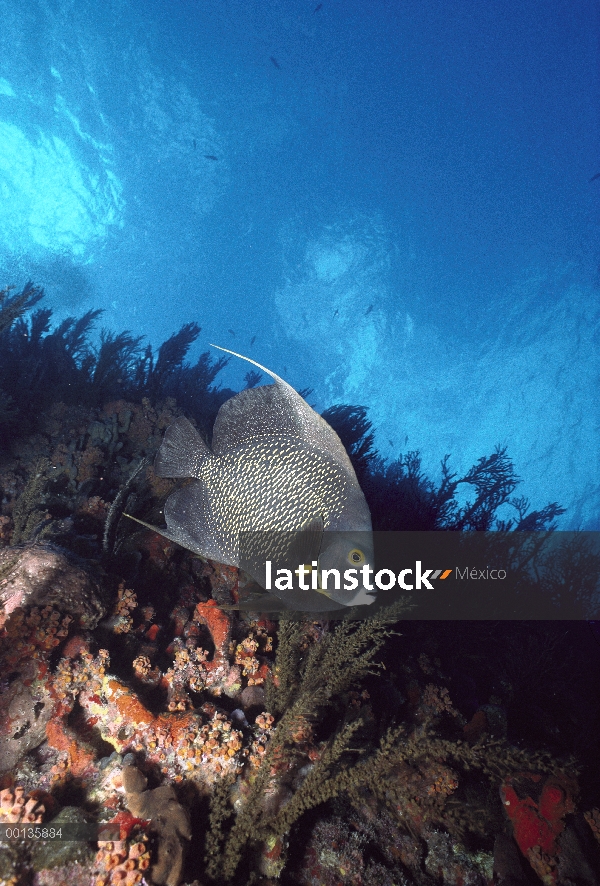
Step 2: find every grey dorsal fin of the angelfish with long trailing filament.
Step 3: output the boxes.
[212,345,354,476]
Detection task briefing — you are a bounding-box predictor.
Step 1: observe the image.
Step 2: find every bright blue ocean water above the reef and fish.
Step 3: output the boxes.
[0,0,600,529]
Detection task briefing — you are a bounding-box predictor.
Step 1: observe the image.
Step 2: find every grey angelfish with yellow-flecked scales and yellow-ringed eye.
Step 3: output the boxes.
[141,345,374,612]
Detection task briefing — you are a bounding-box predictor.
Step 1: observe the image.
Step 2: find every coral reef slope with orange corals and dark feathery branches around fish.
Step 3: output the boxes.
[0,284,600,886]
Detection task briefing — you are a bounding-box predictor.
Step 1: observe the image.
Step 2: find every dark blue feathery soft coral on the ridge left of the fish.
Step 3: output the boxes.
[0,283,233,439]
